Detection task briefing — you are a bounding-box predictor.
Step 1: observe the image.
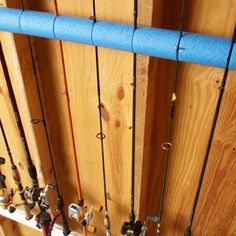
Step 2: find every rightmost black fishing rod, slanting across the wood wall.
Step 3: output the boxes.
[184,24,236,236]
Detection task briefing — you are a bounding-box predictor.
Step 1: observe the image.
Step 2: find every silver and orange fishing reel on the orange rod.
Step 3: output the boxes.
[68,203,103,233]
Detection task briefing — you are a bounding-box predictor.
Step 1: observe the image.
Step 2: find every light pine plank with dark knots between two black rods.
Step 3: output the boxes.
[96,0,133,234]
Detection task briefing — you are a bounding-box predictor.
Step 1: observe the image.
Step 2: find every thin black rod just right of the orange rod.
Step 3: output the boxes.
[92,0,110,236]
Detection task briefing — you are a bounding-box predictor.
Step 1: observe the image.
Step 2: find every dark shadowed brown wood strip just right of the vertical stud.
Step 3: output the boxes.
[137,0,180,235]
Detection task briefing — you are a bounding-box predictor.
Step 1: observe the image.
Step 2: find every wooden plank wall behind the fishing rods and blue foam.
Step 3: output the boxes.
[0,0,236,236]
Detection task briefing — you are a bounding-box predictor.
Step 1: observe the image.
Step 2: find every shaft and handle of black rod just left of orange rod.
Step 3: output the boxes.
[17,0,70,235]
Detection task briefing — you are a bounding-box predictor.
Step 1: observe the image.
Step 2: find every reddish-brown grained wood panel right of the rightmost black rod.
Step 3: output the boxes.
[193,71,236,235]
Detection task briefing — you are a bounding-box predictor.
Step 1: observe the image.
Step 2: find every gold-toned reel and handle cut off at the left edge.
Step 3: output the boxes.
[0,157,14,209]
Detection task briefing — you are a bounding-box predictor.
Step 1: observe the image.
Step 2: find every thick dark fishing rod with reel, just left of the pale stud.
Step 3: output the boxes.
[0,42,42,209]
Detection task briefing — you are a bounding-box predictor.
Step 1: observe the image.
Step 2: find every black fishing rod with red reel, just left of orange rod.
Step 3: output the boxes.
[16,0,71,236]
